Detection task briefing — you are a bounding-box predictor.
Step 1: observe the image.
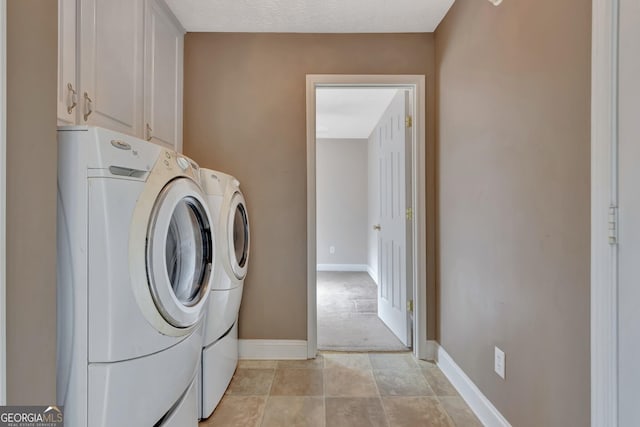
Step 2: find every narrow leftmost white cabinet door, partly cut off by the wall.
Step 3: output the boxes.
[58,0,79,125]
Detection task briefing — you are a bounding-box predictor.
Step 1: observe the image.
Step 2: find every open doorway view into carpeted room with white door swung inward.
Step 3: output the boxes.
[316,87,413,351]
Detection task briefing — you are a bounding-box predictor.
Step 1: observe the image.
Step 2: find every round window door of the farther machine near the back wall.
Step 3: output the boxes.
[227,192,249,280]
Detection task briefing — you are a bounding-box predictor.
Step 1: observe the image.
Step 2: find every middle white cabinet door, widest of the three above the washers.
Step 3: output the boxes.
[78,0,144,137]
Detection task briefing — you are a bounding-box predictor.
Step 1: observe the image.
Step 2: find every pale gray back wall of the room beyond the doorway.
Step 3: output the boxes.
[316,139,368,265]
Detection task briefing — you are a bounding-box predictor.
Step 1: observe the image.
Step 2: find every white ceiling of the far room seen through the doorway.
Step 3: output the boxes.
[316,88,398,138]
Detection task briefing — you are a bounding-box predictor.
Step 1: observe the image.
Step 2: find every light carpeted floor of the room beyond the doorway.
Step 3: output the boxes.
[317,271,407,351]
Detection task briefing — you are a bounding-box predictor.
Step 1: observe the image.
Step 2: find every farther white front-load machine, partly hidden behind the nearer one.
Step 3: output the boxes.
[199,168,249,418]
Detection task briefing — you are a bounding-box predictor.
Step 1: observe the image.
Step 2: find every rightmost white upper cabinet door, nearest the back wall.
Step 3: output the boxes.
[144,0,184,152]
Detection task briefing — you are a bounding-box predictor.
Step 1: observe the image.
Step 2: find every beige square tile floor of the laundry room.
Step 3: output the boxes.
[200,352,482,427]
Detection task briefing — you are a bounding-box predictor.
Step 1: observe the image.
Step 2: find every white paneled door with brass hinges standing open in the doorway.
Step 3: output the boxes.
[377,91,412,346]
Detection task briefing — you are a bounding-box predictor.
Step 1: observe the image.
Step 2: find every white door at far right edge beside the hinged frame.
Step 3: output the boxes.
[618,0,640,426]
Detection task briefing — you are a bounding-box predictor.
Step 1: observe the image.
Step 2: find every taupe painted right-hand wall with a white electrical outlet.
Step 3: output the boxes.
[435,0,592,427]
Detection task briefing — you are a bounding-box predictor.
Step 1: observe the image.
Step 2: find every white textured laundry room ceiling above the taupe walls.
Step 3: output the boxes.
[166,0,454,33]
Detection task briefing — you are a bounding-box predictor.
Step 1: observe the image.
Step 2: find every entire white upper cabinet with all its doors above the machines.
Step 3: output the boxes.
[58,0,184,145]
